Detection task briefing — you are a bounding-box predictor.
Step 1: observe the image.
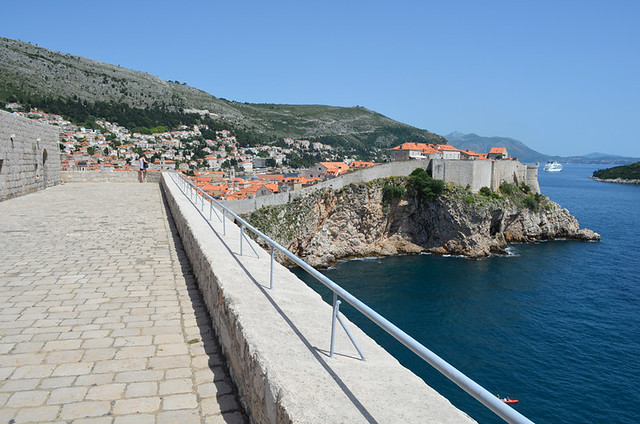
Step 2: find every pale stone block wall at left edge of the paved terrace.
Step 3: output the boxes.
[0,111,60,200]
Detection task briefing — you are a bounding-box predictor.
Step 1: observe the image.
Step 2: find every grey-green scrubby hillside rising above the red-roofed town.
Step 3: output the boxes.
[0,38,446,150]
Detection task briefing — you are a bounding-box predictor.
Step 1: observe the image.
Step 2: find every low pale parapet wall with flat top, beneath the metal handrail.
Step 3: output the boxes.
[161,173,473,424]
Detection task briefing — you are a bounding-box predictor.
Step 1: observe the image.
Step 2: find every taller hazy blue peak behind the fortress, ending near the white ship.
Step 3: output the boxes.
[445,132,553,163]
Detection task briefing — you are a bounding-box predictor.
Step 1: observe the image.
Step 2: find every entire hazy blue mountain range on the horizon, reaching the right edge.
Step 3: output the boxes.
[445,131,638,165]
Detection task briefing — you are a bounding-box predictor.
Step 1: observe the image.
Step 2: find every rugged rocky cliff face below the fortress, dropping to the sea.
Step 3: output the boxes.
[248,179,600,267]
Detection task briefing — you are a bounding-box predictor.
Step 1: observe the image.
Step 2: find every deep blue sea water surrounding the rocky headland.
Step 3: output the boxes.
[292,165,640,423]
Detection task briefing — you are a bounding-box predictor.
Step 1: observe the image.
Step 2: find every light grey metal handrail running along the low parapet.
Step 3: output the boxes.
[170,172,532,424]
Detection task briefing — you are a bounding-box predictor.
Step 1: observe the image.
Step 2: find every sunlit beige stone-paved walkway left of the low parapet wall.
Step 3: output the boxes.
[0,183,247,424]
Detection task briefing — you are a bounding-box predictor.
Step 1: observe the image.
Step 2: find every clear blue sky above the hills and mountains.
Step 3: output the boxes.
[0,0,640,157]
